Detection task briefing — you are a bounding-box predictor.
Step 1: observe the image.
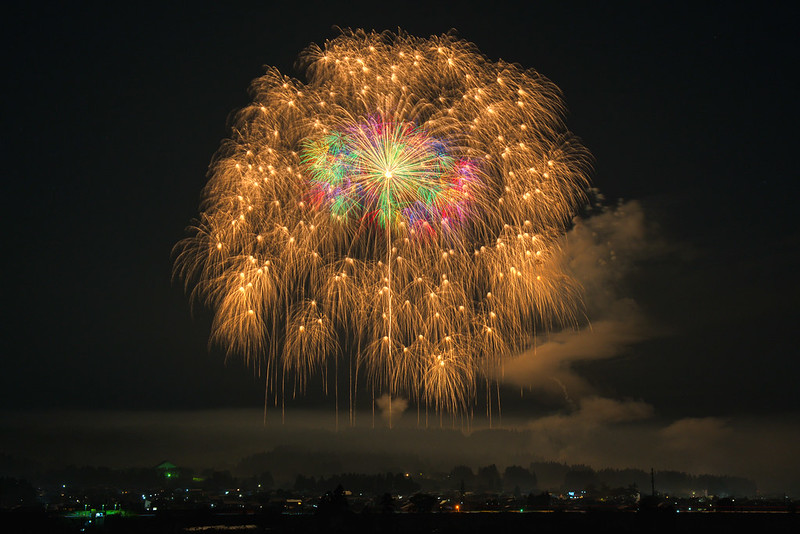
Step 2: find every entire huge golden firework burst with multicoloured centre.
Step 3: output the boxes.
[175,30,588,423]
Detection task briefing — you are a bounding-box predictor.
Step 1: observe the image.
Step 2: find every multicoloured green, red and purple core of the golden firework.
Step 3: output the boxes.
[301,118,477,236]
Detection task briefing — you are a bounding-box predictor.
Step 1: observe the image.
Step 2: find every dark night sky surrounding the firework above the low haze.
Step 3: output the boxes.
[0,2,800,494]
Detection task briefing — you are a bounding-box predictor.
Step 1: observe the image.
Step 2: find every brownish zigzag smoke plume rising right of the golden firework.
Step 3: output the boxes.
[504,201,661,408]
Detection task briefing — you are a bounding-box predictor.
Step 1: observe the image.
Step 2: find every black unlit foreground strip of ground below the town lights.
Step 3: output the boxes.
[0,512,800,534]
